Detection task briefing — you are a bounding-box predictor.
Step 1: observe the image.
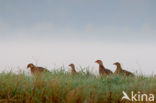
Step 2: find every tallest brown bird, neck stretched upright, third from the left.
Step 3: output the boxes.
[95,60,113,76]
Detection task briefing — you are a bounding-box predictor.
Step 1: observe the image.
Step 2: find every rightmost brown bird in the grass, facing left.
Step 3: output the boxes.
[114,62,134,76]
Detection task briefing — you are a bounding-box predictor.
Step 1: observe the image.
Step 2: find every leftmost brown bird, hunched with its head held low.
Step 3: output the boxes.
[27,63,49,75]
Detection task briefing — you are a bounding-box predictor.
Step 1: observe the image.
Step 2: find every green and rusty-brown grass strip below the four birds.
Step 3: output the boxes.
[0,71,156,103]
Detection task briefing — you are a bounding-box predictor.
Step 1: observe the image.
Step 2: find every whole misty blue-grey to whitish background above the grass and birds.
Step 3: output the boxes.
[0,0,156,74]
